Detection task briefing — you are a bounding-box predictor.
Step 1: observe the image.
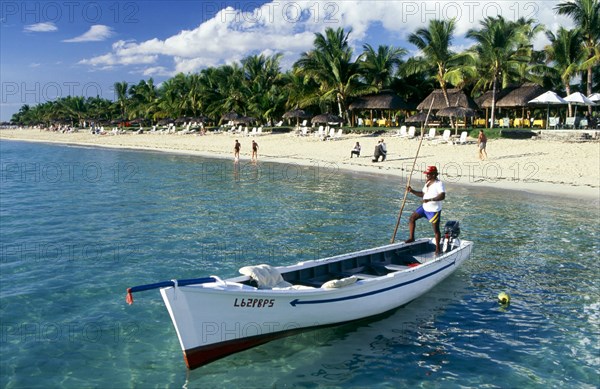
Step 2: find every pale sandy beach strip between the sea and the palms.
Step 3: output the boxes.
[0,129,600,203]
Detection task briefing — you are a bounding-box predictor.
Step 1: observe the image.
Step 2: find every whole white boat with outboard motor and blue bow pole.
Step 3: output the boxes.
[127,222,473,369]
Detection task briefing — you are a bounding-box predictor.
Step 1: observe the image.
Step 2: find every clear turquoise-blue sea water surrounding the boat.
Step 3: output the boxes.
[0,141,600,388]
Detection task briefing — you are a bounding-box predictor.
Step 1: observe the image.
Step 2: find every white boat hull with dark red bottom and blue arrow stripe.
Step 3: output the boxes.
[160,240,472,369]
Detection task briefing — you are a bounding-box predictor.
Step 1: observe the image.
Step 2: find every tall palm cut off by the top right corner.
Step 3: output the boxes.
[554,0,600,113]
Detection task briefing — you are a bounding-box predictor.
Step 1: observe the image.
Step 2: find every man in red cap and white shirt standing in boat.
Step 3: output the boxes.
[405,166,446,255]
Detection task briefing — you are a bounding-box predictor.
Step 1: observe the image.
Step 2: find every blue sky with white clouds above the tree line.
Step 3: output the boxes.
[0,0,572,121]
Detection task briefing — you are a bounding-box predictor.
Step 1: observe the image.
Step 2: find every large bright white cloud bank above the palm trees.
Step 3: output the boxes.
[72,0,568,75]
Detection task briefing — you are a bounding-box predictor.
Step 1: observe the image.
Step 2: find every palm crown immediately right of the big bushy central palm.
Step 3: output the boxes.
[359,44,408,91]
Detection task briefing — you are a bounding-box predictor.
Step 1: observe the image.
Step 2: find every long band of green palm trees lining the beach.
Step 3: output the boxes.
[12,0,600,129]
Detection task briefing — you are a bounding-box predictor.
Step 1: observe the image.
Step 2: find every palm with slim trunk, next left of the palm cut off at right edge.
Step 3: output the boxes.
[544,27,586,116]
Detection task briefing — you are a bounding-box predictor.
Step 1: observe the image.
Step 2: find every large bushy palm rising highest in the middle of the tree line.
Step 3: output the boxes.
[294,28,370,117]
